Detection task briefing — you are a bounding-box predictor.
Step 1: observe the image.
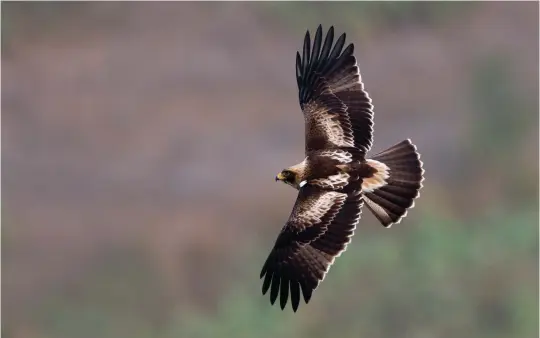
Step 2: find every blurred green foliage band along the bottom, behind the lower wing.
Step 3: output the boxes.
[31,208,538,338]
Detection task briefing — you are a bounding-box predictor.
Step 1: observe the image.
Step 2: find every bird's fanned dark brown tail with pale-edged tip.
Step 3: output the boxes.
[364,139,424,227]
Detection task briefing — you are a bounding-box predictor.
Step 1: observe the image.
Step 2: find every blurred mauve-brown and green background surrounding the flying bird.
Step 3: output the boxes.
[2,2,539,338]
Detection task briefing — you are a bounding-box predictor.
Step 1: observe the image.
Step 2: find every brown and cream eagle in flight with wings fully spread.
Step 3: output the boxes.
[260,26,424,312]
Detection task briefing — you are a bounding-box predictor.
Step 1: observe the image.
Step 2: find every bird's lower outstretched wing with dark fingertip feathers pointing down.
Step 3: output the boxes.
[261,185,362,312]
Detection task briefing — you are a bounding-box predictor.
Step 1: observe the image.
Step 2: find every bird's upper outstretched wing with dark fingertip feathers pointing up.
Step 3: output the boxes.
[296,25,373,155]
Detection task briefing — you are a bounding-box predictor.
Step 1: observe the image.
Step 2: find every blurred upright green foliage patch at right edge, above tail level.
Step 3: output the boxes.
[462,54,538,204]
